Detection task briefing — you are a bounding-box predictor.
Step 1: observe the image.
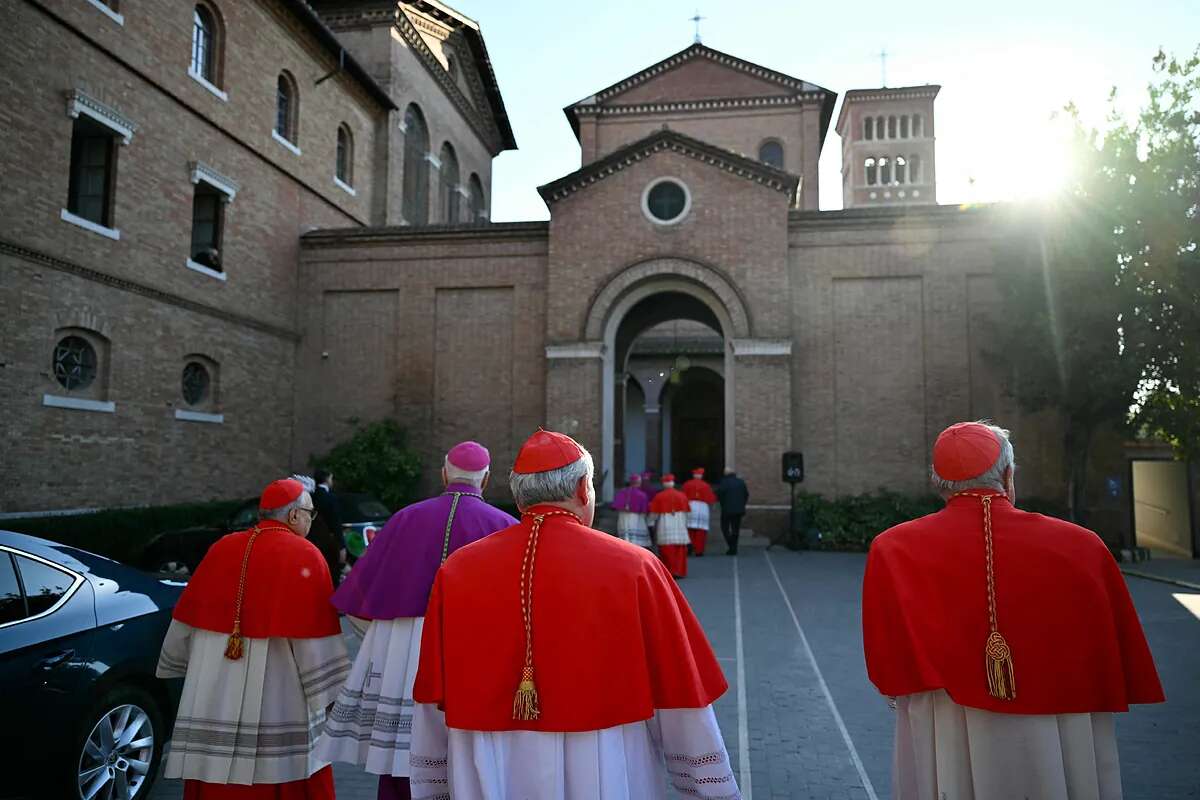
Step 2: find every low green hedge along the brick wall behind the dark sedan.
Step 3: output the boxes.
[0,499,246,561]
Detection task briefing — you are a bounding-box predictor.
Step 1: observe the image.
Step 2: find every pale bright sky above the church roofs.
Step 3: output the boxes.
[449,0,1200,222]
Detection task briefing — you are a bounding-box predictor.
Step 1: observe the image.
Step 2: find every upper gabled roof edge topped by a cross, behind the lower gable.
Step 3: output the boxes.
[563,43,838,148]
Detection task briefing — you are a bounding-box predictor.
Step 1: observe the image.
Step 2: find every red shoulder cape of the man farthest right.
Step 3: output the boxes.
[863,497,1163,714]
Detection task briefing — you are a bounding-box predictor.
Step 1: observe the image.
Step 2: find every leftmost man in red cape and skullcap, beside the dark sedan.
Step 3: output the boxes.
[156,480,350,800]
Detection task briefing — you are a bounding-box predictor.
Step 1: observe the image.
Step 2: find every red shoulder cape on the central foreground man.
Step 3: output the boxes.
[413,517,727,732]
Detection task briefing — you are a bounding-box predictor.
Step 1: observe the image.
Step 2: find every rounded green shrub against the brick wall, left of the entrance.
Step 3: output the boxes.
[312,420,421,509]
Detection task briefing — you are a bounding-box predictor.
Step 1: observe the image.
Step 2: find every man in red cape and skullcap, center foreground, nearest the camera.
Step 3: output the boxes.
[410,429,740,800]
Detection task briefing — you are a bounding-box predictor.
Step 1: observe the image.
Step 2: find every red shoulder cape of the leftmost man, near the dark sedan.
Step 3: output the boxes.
[172,522,341,639]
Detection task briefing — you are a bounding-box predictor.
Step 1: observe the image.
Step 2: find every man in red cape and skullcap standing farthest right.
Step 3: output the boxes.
[863,422,1164,800]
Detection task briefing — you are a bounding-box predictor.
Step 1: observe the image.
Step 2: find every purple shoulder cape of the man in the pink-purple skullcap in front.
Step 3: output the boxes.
[331,483,517,619]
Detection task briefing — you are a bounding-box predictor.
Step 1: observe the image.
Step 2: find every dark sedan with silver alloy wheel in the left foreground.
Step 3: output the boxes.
[0,530,184,800]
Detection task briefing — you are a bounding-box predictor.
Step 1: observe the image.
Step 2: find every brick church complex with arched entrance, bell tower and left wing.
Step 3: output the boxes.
[0,0,1089,537]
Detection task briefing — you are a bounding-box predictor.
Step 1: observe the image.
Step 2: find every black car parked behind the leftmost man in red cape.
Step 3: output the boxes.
[133,493,391,578]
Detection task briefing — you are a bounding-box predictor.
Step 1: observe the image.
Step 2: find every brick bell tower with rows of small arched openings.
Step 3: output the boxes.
[836,85,941,209]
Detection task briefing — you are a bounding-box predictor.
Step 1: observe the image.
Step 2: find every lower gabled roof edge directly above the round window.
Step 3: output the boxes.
[538,128,800,206]
